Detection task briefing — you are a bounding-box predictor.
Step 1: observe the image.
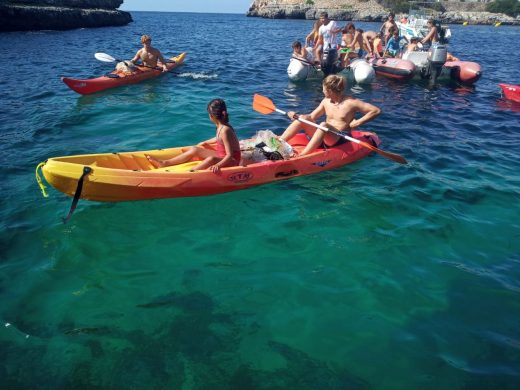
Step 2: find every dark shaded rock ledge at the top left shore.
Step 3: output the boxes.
[0,0,132,31]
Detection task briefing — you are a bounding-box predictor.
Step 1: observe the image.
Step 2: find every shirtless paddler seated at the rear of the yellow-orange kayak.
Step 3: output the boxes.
[280,75,381,156]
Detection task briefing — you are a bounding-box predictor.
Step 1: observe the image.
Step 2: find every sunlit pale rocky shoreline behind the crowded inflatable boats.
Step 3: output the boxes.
[246,0,520,25]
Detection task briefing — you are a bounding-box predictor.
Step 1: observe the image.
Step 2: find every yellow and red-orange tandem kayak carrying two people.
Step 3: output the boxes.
[37,131,380,202]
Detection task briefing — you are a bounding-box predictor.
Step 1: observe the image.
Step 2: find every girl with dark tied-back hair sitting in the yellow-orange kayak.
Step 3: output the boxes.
[146,99,241,173]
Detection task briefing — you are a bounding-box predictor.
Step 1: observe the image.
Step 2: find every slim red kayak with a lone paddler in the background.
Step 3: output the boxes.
[61,53,186,95]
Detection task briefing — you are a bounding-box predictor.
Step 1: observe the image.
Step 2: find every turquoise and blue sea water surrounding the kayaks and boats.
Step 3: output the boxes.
[0,12,520,389]
